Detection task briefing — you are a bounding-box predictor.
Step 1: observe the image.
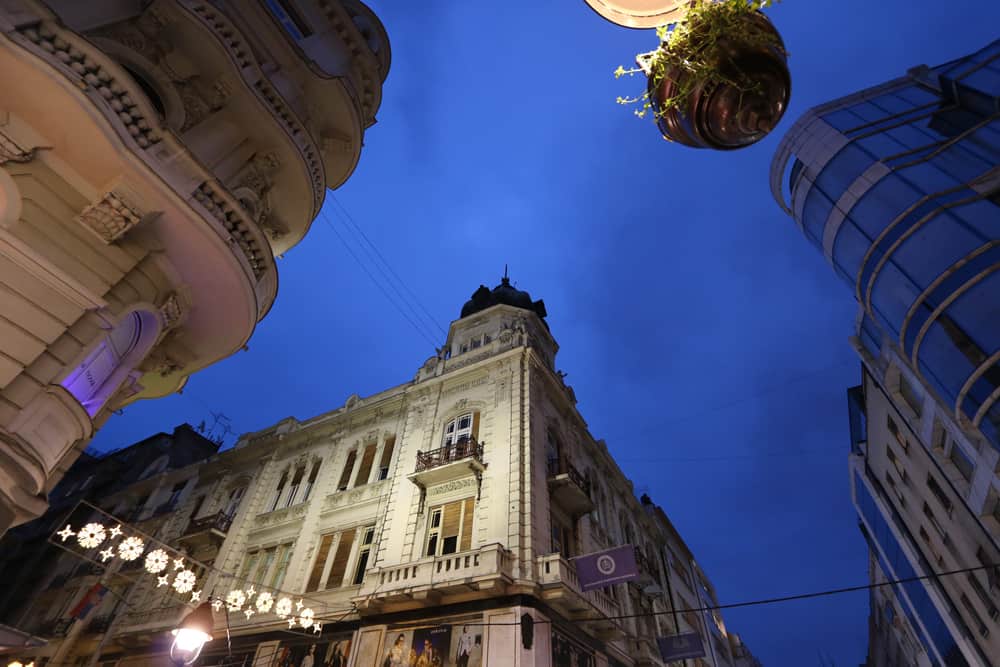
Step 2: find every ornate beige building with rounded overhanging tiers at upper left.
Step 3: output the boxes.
[0,0,390,534]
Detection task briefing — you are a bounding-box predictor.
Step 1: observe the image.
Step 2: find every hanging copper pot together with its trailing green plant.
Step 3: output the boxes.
[615,0,791,150]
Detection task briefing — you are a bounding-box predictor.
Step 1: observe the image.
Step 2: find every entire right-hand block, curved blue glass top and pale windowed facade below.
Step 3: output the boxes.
[771,41,1000,665]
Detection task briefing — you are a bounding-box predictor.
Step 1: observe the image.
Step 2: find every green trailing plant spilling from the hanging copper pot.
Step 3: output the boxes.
[615,0,788,120]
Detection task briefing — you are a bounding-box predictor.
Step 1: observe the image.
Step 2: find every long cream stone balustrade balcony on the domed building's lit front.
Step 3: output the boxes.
[354,544,513,612]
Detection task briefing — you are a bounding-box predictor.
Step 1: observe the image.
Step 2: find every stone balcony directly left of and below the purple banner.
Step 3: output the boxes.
[537,554,624,641]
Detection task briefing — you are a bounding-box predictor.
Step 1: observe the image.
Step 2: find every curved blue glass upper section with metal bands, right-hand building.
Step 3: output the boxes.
[771,40,1000,449]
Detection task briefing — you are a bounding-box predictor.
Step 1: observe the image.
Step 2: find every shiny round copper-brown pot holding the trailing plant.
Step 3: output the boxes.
[649,12,792,150]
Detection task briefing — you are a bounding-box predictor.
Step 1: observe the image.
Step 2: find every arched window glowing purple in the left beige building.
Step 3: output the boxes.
[60,310,159,417]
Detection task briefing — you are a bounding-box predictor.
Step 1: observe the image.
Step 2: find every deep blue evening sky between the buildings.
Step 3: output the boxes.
[88,0,1000,667]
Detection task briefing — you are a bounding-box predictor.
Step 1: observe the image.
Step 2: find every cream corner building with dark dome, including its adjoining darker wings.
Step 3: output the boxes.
[0,279,755,667]
